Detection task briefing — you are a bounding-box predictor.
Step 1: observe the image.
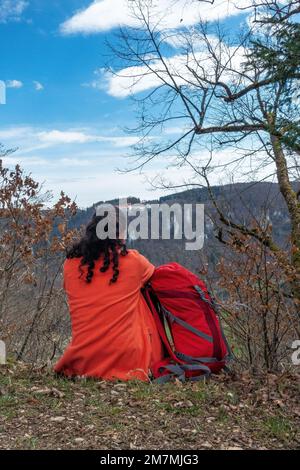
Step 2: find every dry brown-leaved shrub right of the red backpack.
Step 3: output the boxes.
[217,233,300,372]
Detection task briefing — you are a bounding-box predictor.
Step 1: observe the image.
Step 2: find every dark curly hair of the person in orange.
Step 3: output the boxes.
[67,207,128,284]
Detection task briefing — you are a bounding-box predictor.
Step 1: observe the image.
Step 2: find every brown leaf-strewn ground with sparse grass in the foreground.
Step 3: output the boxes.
[0,363,300,450]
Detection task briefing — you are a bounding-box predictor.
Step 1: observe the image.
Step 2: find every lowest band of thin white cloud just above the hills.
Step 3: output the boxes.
[0,126,273,206]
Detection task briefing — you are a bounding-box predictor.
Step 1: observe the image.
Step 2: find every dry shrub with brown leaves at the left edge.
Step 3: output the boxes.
[0,160,76,362]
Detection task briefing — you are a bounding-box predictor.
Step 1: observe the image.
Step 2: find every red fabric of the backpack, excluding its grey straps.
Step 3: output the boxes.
[151,263,228,376]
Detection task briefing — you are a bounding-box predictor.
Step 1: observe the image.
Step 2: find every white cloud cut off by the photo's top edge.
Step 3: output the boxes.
[60,0,251,34]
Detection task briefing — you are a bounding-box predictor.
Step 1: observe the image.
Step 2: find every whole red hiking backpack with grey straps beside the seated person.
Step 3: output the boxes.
[143,263,232,383]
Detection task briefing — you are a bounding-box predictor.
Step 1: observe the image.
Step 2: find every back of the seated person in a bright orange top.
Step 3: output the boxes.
[55,211,162,381]
